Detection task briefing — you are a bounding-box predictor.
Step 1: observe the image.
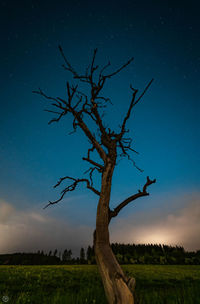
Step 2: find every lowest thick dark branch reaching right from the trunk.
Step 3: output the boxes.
[109,176,156,222]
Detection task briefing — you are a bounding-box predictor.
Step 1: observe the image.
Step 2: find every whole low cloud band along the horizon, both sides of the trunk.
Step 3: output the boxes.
[0,195,200,255]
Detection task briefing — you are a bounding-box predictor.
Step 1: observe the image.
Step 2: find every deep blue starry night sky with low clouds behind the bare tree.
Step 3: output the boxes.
[0,0,200,253]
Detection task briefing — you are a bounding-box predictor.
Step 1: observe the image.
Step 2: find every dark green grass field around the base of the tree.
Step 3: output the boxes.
[0,265,200,304]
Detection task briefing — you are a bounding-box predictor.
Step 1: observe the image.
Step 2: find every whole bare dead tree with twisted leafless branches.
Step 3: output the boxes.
[34,46,156,304]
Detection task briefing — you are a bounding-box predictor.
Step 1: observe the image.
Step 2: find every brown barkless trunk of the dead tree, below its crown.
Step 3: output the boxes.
[94,164,135,304]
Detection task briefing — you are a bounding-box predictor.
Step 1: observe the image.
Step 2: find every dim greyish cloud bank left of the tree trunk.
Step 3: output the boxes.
[0,201,93,255]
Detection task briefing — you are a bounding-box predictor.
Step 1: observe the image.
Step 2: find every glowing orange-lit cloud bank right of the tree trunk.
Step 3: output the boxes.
[111,195,200,250]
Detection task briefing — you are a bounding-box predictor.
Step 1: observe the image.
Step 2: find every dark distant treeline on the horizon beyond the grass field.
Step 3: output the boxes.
[0,243,200,265]
